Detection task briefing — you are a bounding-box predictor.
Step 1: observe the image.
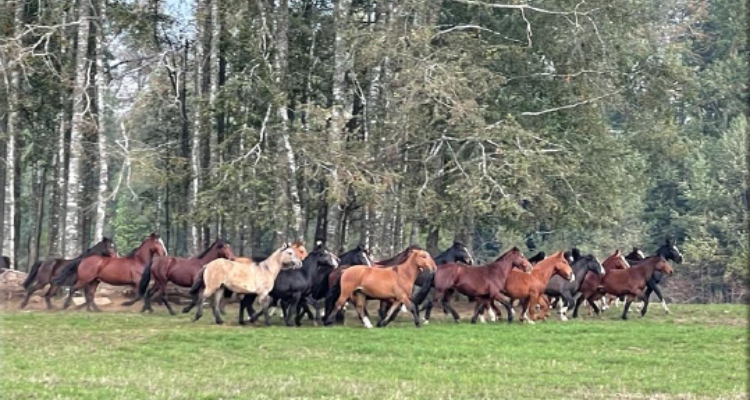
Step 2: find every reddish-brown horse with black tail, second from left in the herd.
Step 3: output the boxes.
[52,232,167,311]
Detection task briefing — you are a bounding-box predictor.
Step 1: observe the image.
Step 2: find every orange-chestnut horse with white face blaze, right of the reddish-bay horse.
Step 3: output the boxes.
[471,251,575,324]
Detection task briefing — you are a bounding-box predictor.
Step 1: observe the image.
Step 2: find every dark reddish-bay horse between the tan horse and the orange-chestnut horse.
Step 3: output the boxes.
[425,247,532,322]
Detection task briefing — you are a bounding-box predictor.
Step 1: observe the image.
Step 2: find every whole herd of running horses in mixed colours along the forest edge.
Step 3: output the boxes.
[11,233,682,328]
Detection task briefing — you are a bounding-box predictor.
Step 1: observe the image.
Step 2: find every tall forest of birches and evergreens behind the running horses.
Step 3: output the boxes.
[0,0,750,303]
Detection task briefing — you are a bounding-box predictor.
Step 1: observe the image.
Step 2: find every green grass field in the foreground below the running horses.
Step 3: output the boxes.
[0,305,748,400]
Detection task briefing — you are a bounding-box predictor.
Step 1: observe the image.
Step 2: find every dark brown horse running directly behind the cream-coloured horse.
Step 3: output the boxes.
[136,239,234,315]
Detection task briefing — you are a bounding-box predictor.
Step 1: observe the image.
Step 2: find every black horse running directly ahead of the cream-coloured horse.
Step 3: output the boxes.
[240,242,339,326]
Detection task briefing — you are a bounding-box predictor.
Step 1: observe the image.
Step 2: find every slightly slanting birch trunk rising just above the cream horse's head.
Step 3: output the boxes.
[274,0,305,239]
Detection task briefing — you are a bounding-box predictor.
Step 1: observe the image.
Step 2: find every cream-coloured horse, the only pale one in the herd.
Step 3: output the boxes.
[193,243,302,325]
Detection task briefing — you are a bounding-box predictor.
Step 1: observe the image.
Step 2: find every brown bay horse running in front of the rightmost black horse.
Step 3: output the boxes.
[598,256,672,319]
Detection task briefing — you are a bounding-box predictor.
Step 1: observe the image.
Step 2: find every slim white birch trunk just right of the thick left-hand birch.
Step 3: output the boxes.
[93,0,109,242]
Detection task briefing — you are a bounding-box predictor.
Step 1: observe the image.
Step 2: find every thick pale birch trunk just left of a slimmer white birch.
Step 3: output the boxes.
[65,0,90,258]
